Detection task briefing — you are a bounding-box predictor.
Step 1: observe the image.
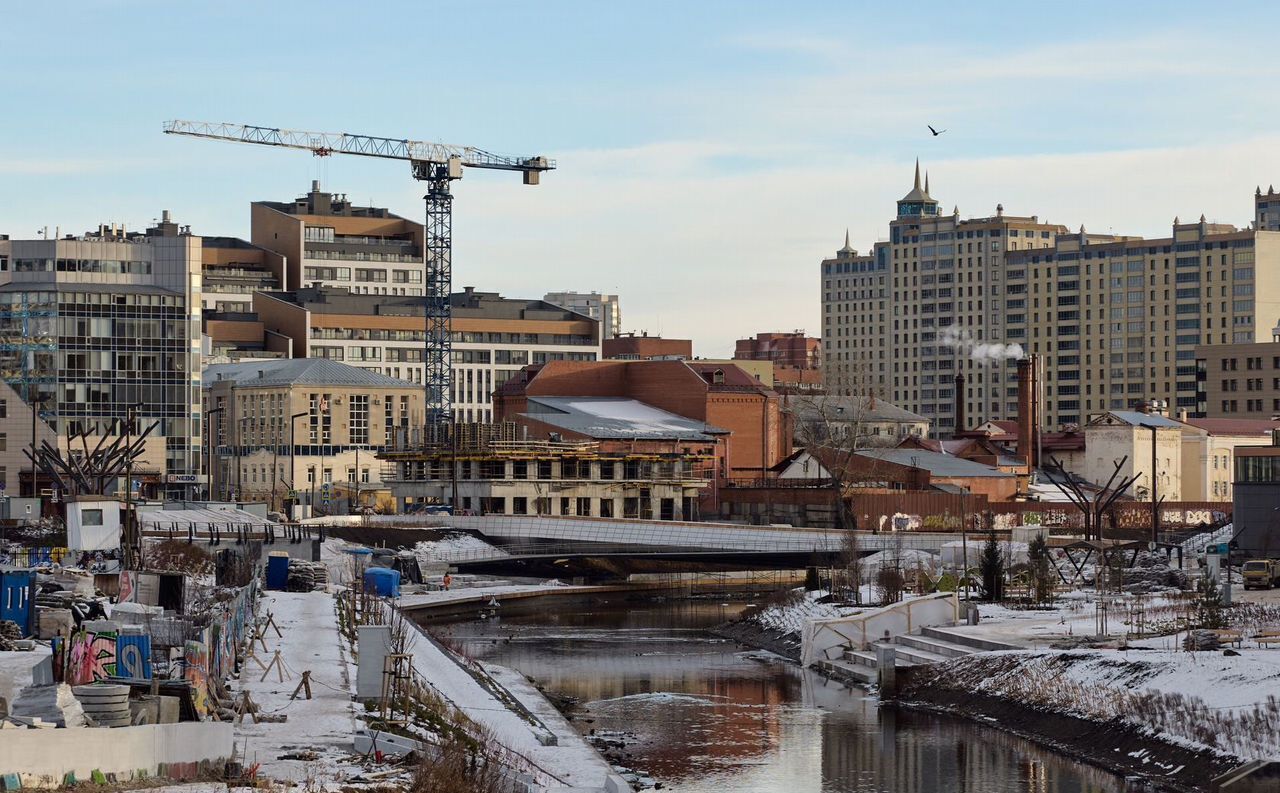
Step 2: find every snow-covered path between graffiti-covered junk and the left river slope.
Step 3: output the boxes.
[233,592,361,783]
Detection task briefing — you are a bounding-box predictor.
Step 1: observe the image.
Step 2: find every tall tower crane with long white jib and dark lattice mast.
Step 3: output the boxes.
[164,122,556,440]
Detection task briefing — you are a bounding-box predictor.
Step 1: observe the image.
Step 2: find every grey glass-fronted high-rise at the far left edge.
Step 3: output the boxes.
[0,214,202,496]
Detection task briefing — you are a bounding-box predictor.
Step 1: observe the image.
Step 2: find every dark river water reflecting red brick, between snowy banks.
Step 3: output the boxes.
[431,601,1124,793]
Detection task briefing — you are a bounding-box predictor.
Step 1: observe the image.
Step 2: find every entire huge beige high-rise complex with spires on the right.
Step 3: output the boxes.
[822,161,1280,434]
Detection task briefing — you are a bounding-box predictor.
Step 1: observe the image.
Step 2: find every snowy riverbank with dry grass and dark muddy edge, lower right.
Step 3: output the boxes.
[899,650,1264,789]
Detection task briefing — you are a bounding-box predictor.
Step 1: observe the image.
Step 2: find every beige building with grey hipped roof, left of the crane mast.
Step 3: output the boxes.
[204,358,424,514]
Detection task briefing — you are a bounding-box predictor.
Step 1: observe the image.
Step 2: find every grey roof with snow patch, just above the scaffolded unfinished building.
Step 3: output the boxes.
[524,397,728,441]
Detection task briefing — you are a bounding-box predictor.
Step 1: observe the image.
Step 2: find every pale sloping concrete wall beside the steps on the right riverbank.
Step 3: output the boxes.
[800,592,960,666]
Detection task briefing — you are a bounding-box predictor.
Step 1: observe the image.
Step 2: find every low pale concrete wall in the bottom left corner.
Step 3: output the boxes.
[0,721,233,788]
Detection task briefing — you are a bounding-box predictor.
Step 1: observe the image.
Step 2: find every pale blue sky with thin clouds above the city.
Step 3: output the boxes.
[0,0,1280,357]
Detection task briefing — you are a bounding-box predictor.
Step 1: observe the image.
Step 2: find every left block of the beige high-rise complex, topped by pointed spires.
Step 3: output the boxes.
[822,164,1066,434]
